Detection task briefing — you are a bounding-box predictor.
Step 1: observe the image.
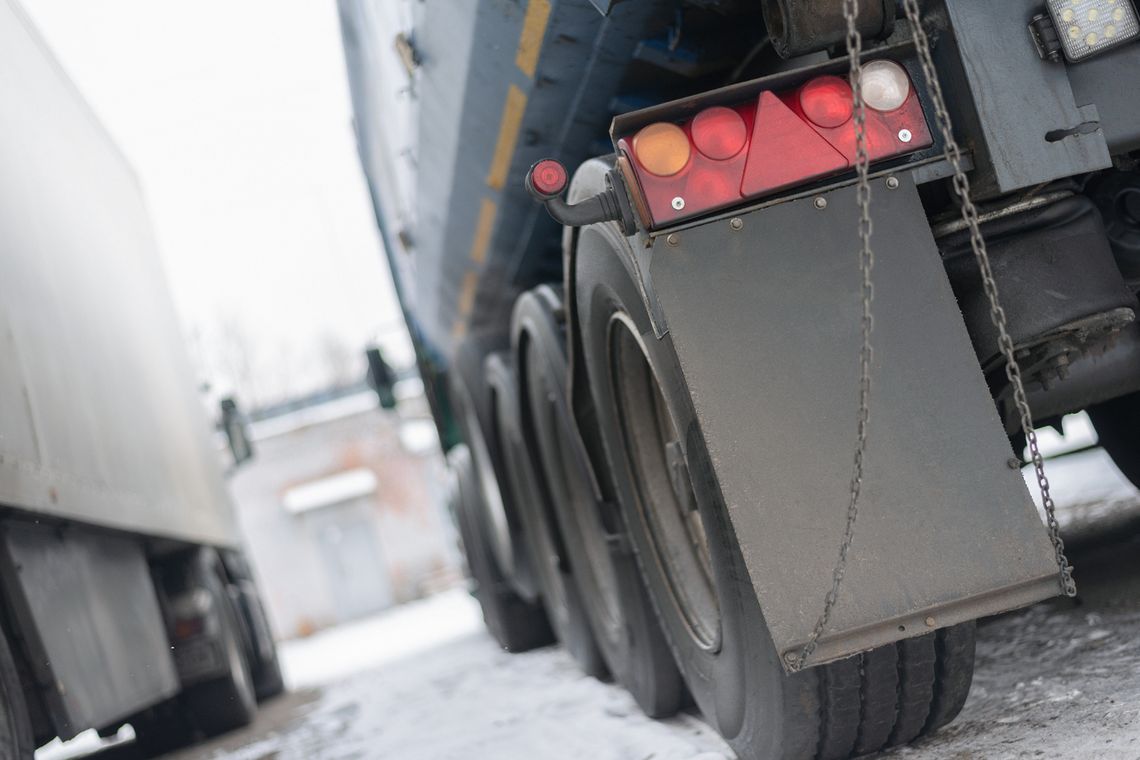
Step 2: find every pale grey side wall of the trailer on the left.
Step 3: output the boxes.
[0,0,237,545]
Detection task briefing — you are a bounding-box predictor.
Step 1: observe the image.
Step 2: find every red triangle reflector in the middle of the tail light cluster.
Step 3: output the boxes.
[740,92,848,196]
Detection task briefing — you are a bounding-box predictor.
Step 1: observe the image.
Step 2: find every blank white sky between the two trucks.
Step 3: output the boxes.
[23,0,410,403]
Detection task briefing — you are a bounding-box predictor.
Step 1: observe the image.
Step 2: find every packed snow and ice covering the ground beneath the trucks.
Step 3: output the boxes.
[55,451,1140,760]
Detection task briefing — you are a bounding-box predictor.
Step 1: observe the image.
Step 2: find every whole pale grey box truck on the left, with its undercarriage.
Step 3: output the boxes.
[0,0,284,760]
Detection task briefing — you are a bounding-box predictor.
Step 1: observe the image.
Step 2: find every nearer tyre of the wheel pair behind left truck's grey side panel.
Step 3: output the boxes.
[182,575,258,736]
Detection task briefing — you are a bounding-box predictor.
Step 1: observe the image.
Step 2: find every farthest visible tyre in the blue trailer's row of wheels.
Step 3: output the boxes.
[447,443,554,652]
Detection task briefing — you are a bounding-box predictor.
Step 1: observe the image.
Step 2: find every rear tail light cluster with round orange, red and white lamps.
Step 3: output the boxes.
[618,60,933,227]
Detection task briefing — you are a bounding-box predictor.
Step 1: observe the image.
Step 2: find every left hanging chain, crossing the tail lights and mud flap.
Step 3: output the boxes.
[791,0,874,670]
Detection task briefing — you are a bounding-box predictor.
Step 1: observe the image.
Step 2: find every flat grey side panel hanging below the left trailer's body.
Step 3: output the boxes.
[0,521,179,738]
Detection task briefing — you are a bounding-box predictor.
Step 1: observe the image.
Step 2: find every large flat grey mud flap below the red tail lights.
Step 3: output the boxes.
[646,174,1060,664]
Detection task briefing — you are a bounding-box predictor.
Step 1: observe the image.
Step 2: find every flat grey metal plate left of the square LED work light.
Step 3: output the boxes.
[928,0,1112,199]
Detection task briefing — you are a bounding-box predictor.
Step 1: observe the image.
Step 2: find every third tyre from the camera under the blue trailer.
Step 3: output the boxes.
[486,352,608,678]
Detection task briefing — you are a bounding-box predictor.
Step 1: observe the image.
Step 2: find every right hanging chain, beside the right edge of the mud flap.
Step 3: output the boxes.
[903,0,1076,596]
